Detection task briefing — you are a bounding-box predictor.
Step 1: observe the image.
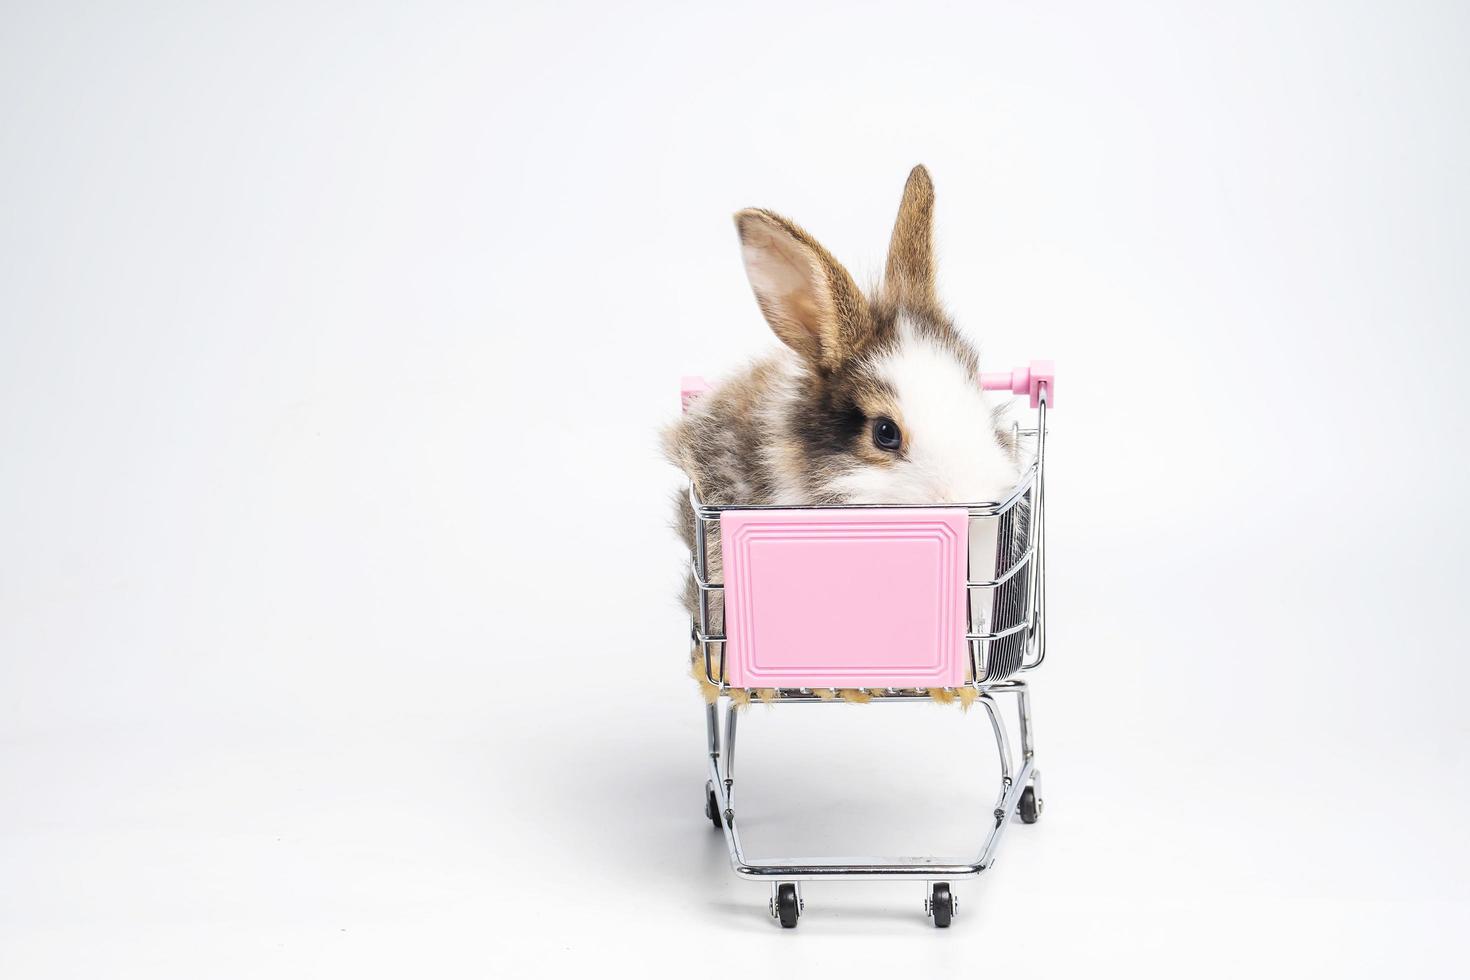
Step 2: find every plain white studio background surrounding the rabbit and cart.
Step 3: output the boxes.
[0,3,1470,979]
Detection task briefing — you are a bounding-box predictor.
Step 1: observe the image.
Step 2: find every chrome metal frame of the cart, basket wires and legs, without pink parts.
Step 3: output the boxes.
[689,388,1047,909]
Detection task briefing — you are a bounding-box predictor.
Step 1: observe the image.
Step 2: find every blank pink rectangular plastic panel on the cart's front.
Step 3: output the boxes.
[720,508,969,688]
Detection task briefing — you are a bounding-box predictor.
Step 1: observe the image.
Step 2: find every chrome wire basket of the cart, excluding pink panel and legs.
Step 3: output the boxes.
[689,392,1047,701]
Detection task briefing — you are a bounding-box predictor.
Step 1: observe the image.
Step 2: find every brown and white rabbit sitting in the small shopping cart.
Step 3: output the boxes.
[663,166,1020,702]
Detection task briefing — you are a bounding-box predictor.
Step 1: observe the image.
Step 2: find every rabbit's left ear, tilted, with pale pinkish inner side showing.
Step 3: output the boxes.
[735,207,872,370]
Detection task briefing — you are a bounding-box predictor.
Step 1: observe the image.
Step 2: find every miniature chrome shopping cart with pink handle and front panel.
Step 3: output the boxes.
[684,361,1055,929]
